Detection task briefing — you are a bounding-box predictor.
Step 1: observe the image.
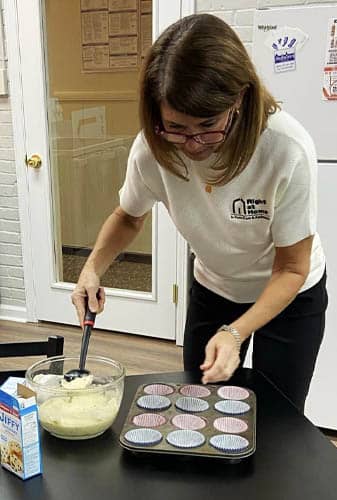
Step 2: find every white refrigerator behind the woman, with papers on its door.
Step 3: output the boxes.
[252,5,337,429]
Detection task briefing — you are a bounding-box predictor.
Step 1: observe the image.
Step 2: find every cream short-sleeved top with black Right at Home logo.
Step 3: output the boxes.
[120,111,325,303]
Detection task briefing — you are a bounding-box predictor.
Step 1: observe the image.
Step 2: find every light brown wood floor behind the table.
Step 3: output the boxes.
[0,320,337,446]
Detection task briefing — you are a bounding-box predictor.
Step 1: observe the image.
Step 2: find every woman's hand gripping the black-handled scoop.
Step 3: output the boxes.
[71,269,105,328]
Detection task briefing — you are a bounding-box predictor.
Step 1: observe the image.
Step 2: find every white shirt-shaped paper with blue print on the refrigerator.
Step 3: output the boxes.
[265,26,309,73]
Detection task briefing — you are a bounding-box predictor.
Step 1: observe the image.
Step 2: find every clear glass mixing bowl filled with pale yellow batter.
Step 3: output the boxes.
[26,356,125,439]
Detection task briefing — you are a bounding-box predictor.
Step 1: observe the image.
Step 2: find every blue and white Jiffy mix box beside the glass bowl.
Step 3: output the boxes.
[0,377,42,479]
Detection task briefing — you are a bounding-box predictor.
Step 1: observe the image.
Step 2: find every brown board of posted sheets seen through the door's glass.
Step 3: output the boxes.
[81,0,152,73]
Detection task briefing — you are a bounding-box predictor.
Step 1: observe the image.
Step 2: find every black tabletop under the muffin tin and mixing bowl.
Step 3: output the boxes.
[0,369,337,500]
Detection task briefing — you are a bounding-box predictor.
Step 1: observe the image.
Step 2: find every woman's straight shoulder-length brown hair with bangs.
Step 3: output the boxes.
[140,14,278,184]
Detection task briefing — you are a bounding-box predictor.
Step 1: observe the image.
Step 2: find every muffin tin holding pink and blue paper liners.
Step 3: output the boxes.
[119,382,256,460]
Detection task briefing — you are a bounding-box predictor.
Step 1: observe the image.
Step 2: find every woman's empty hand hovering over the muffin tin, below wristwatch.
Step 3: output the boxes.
[200,331,240,384]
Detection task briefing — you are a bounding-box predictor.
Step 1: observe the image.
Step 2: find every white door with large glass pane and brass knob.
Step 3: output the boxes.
[9,0,186,339]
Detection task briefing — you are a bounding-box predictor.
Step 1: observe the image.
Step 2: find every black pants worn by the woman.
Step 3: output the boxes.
[184,273,328,412]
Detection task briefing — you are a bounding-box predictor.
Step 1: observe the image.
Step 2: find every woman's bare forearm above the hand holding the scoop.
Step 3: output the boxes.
[83,207,146,277]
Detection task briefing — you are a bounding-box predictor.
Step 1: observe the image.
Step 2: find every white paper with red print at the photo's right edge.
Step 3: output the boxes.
[323,17,337,101]
